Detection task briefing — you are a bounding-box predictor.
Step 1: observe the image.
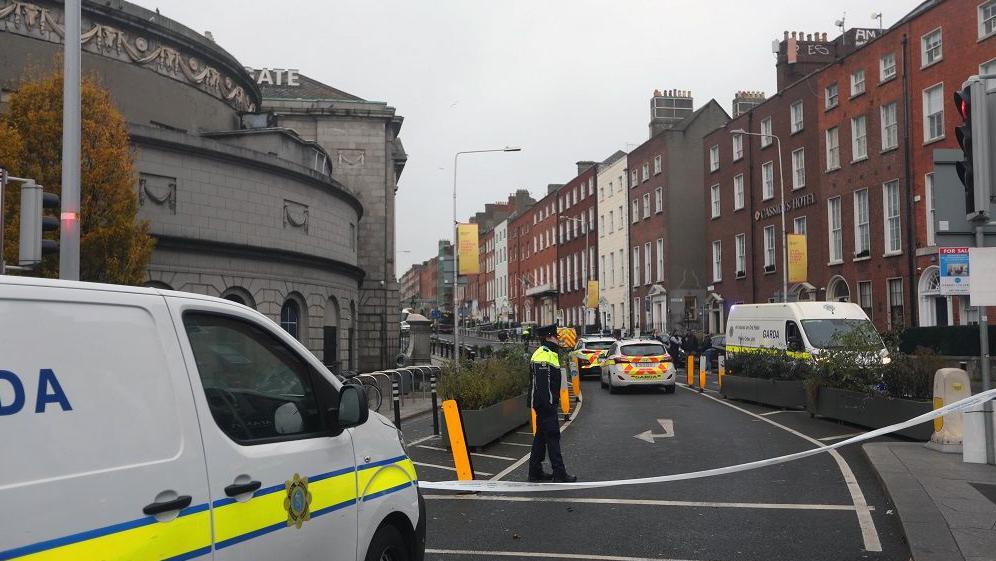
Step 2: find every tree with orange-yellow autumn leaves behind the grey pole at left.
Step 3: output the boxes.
[0,72,155,284]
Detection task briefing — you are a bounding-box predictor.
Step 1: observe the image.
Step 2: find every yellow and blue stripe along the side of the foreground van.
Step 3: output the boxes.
[0,456,418,561]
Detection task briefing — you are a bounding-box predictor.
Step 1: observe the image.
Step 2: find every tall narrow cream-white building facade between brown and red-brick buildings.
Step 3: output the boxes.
[596,150,629,333]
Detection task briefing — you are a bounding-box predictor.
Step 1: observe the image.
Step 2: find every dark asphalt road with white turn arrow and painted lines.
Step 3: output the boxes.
[402,377,919,561]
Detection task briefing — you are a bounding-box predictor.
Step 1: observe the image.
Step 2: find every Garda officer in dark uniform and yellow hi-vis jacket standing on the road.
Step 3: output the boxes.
[529,325,578,483]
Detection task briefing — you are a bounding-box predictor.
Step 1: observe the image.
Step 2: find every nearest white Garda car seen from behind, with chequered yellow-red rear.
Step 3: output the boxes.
[601,339,676,393]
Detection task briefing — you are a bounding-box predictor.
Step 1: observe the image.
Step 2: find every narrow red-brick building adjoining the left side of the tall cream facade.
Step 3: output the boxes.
[555,162,598,333]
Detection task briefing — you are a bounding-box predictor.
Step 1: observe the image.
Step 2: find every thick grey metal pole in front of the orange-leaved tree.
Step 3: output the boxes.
[59,0,82,280]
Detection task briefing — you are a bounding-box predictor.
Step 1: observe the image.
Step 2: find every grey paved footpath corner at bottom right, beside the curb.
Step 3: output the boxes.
[863,442,996,561]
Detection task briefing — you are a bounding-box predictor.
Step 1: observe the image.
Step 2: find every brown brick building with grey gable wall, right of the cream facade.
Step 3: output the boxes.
[626,90,729,334]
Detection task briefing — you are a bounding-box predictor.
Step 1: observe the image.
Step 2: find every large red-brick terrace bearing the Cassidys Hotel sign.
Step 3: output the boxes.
[703,0,996,331]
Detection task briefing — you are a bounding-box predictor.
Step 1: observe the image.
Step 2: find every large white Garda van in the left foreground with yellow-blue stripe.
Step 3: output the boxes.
[0,277,425,561]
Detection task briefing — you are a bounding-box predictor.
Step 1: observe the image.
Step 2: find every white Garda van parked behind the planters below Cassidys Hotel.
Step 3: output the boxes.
[726,302,891,364]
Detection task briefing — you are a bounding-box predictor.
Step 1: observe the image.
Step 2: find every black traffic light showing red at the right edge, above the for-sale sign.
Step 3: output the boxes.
[954,76,996,220]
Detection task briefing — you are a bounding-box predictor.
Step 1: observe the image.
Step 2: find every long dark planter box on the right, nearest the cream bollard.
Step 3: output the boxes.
[806,388,934,440]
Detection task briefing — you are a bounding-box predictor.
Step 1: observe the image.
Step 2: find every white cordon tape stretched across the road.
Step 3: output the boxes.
[418,389,996,493]
